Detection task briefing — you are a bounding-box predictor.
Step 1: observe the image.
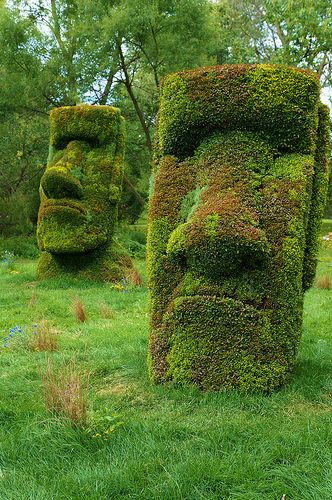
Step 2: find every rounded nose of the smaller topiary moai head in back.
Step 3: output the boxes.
[41,167,83,199]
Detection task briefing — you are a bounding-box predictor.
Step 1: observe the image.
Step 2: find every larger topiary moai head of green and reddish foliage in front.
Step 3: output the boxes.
[148,65,329,391]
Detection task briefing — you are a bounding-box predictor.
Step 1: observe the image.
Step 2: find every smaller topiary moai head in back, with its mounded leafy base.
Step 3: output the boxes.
[37,105,130,279]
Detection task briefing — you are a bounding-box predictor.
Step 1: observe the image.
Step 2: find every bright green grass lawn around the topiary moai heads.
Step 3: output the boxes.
[0,221,332,500]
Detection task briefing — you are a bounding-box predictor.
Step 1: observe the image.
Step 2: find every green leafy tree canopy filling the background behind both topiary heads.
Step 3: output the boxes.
[0,0,332,231]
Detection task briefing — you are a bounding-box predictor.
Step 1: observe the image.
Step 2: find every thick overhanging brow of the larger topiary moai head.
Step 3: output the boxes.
[158,65,319,158]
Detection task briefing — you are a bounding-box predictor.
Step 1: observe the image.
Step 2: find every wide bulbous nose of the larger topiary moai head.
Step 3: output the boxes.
[167,206,270,278]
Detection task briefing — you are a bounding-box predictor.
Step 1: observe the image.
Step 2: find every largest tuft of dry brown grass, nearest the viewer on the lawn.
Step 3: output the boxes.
[41,359,89,427]
